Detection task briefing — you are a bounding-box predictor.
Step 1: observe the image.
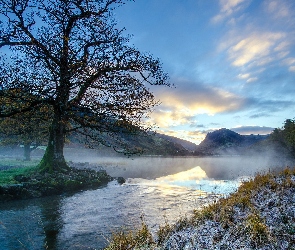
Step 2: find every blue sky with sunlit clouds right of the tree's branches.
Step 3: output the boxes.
[115,0,295,144]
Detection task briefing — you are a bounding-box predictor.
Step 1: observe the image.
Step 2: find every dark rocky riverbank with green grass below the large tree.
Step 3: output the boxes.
[0,163,117,202]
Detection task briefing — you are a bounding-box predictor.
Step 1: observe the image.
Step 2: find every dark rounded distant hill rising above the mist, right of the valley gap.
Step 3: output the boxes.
[194,128,268,156]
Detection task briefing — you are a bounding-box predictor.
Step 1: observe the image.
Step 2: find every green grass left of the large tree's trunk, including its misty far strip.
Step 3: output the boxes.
[0,159,38,185]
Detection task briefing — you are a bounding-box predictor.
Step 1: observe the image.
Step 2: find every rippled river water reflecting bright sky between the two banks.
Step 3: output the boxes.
[0,157,287,250]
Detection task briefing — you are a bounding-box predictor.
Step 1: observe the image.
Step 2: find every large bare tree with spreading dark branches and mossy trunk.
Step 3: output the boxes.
[0,0,169,171]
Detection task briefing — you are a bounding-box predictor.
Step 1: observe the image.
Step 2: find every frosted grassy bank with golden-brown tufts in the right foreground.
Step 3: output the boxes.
[106,168,295,250]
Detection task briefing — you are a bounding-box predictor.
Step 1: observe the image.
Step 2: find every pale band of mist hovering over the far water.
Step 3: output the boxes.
[65,146,294,180]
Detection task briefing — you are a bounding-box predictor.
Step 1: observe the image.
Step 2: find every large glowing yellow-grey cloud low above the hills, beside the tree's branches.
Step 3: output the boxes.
[151,80,246,127]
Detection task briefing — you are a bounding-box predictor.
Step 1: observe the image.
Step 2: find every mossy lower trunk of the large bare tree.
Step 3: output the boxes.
[39,115,69,172]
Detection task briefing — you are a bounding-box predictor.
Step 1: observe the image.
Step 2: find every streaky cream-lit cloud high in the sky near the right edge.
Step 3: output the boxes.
[217,27,295,83]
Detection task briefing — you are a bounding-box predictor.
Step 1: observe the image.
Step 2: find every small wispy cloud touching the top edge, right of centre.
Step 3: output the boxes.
[211,0,249,23]
